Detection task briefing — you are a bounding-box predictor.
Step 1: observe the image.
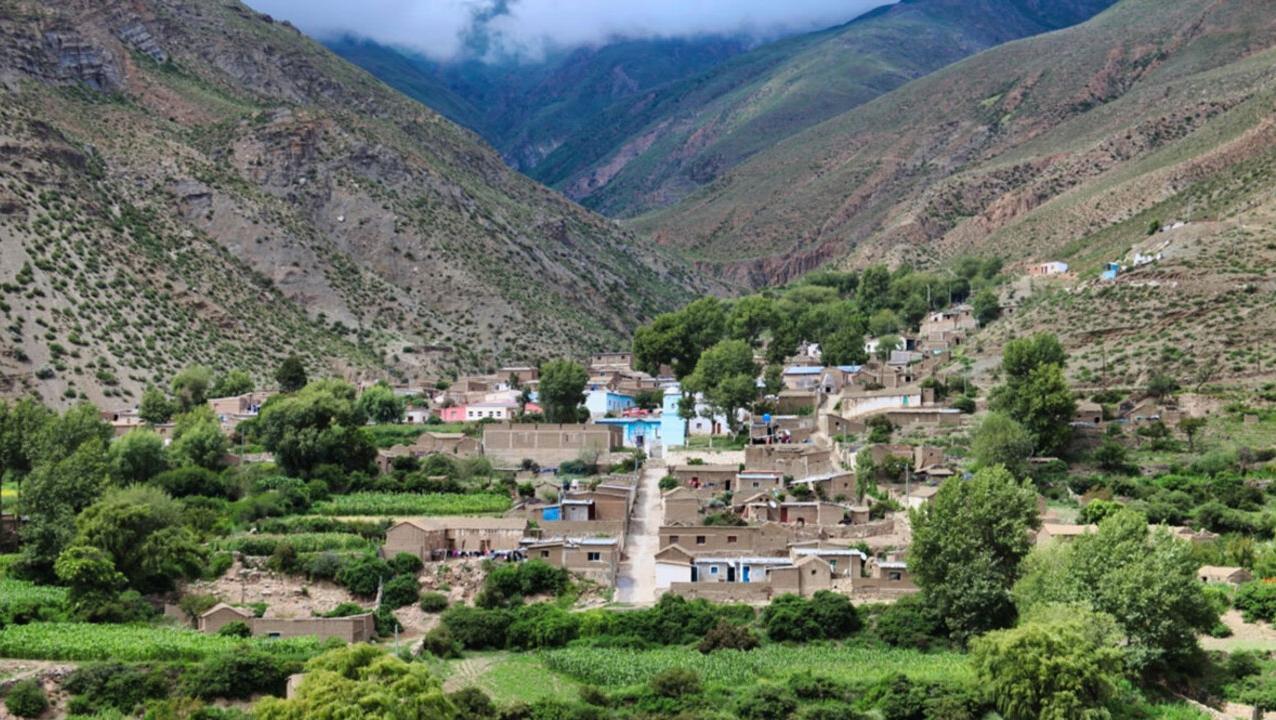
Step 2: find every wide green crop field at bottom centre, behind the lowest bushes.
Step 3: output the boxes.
[542,645,971,687]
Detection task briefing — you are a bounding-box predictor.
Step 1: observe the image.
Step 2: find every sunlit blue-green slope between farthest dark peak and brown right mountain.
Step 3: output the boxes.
[530,0,1113,217]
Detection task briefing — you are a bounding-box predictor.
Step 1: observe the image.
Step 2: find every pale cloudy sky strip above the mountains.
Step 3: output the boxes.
[246,0,893,60]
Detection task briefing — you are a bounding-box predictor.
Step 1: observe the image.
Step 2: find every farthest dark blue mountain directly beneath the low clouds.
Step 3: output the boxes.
[325,36,750,172]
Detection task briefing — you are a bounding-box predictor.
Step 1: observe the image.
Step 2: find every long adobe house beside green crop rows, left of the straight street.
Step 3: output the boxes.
[382,517,527,562]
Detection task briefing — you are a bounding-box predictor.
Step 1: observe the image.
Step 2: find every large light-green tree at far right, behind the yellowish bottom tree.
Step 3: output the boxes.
[1014,509,1219,673]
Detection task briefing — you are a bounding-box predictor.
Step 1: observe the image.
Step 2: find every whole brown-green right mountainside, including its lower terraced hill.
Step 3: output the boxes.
[635,0,1276,385]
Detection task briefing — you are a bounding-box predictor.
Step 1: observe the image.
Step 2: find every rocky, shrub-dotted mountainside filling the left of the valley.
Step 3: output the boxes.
[0,0,697,405]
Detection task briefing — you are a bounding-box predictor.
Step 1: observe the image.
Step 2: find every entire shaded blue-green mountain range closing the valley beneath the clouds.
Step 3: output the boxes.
[328,0,1113,217]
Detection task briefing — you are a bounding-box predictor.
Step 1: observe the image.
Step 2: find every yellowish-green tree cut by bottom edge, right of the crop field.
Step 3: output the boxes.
[971,606,1122,720]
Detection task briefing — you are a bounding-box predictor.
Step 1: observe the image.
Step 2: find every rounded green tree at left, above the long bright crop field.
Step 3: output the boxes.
[71,485,205,592]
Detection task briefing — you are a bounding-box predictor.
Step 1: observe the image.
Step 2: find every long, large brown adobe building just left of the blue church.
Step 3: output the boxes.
[482,423,624,467]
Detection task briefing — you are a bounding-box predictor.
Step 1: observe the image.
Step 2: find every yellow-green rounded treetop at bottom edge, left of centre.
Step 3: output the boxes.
[253,645,458,720]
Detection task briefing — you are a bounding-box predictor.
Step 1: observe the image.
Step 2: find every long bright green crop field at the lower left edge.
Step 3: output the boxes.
[0,623,323,663]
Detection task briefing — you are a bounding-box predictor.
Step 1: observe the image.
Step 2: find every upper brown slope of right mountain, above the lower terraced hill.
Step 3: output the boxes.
[638,0,1276,282]
